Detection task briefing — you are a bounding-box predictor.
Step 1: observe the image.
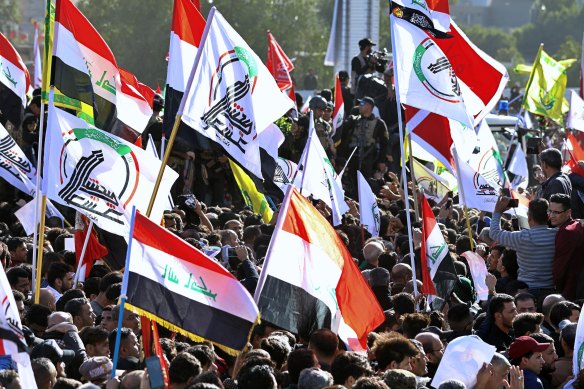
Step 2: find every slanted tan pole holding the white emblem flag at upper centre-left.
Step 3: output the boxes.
[146,7,216,217]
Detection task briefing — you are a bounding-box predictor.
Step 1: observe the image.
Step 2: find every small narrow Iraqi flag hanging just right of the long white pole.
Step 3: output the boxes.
[420,196,458,308]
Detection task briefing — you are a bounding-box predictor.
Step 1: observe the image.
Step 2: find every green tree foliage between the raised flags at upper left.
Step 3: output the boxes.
[78,0,172,87]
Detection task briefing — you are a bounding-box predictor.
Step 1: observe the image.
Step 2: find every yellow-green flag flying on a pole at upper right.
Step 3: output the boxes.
[518,45,573,125]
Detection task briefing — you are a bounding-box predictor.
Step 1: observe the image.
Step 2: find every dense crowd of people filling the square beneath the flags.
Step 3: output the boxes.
[0,34,584,389]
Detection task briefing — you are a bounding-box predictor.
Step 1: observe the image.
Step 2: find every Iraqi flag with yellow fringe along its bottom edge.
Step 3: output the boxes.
[126,213,259,355]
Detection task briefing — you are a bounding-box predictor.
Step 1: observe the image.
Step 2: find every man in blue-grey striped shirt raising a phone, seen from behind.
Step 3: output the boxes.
[489,196,557,301]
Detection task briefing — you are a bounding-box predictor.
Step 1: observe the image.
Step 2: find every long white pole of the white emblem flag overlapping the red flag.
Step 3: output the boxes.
[389,15,418,297]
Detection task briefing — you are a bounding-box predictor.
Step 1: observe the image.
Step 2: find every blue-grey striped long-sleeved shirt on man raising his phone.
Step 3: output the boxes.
[489,213,558,289]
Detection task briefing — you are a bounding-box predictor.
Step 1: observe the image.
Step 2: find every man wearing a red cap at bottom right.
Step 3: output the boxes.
[509,336,550,389]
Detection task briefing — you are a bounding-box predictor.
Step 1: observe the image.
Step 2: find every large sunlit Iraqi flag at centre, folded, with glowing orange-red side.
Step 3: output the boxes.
[255,187,384,348]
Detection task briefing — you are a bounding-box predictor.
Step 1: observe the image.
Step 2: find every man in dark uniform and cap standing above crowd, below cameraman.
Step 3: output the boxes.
[337,96,389,198]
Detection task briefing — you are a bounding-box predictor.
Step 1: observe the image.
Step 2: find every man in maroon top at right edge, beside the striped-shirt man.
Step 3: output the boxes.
[548,194,584,301]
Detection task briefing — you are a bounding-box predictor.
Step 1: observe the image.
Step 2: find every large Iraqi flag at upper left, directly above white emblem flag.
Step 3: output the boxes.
[52,0,152,143]
